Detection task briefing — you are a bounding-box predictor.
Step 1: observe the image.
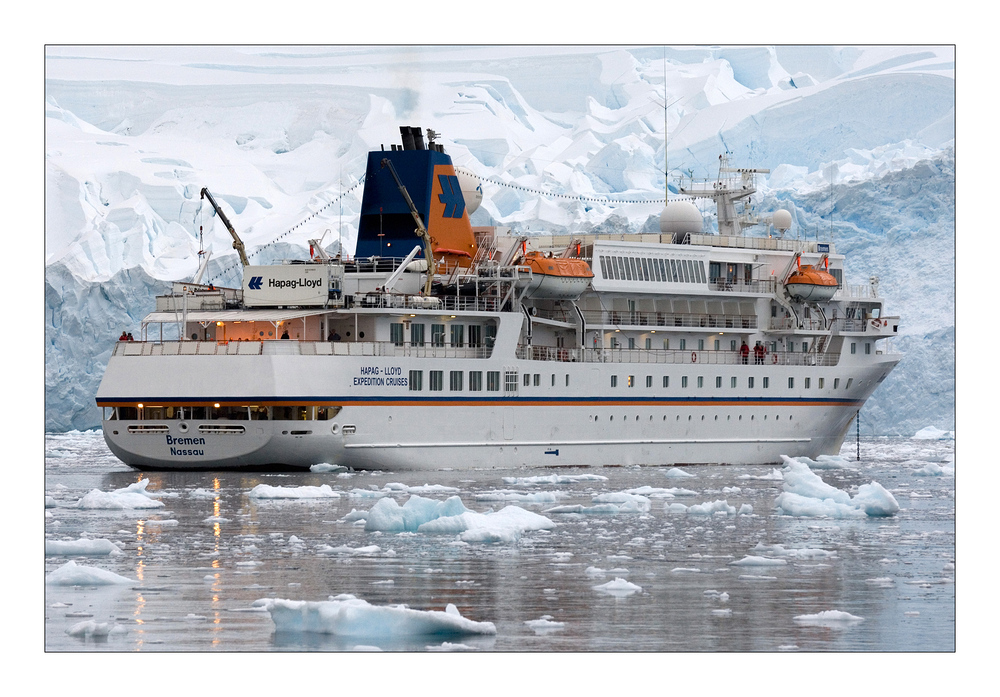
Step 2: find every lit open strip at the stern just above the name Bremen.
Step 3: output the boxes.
[105,404,341,421]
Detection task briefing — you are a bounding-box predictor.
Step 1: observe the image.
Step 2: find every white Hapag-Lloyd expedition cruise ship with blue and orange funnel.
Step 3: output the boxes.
[97,127,900,470]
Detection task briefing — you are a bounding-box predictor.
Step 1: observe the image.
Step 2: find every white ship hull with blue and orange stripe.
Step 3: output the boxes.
[102,344,896,470]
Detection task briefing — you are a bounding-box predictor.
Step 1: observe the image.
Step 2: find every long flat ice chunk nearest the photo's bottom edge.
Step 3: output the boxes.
[254,594,497,637]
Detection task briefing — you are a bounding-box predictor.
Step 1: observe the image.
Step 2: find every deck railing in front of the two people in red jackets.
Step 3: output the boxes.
[517,344,840,366]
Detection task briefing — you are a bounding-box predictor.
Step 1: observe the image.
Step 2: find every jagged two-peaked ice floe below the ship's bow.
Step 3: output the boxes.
[774,455,899,518]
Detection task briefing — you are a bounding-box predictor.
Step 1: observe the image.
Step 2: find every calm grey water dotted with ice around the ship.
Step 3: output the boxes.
[45,433,955,652]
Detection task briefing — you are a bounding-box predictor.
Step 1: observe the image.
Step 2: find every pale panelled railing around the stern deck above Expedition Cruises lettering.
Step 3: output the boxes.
[113,339,493,358]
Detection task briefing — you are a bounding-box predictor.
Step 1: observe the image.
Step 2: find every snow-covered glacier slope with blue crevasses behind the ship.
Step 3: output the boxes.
[45,46,955,434]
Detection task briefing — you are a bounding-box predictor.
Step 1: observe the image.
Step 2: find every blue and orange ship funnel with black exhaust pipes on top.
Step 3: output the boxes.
[354,126,476,266]
